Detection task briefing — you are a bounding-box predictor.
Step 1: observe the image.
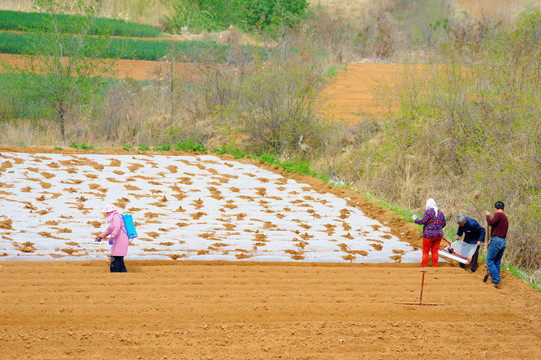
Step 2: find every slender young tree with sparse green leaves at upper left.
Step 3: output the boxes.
[4,0,122,140]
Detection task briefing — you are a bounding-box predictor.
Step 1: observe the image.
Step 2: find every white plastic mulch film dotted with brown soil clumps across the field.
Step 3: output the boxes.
[0,152,421,263]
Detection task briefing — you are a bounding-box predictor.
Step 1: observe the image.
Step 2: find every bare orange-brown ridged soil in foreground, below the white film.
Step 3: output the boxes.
[0,260,541,359]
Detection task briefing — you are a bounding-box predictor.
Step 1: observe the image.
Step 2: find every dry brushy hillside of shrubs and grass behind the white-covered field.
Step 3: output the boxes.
[0,0,541,282]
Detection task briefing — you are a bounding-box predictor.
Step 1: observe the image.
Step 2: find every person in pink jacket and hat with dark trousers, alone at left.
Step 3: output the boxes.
[96,204,130,272]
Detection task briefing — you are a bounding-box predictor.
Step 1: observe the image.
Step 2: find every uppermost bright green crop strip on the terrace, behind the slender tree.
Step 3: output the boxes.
[0,10,163,37]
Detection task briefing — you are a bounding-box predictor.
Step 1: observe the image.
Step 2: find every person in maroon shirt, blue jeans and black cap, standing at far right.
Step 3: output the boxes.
[485,201,509,289]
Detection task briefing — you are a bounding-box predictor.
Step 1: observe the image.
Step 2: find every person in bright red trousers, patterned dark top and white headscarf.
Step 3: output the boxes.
[412,198,447,267]
